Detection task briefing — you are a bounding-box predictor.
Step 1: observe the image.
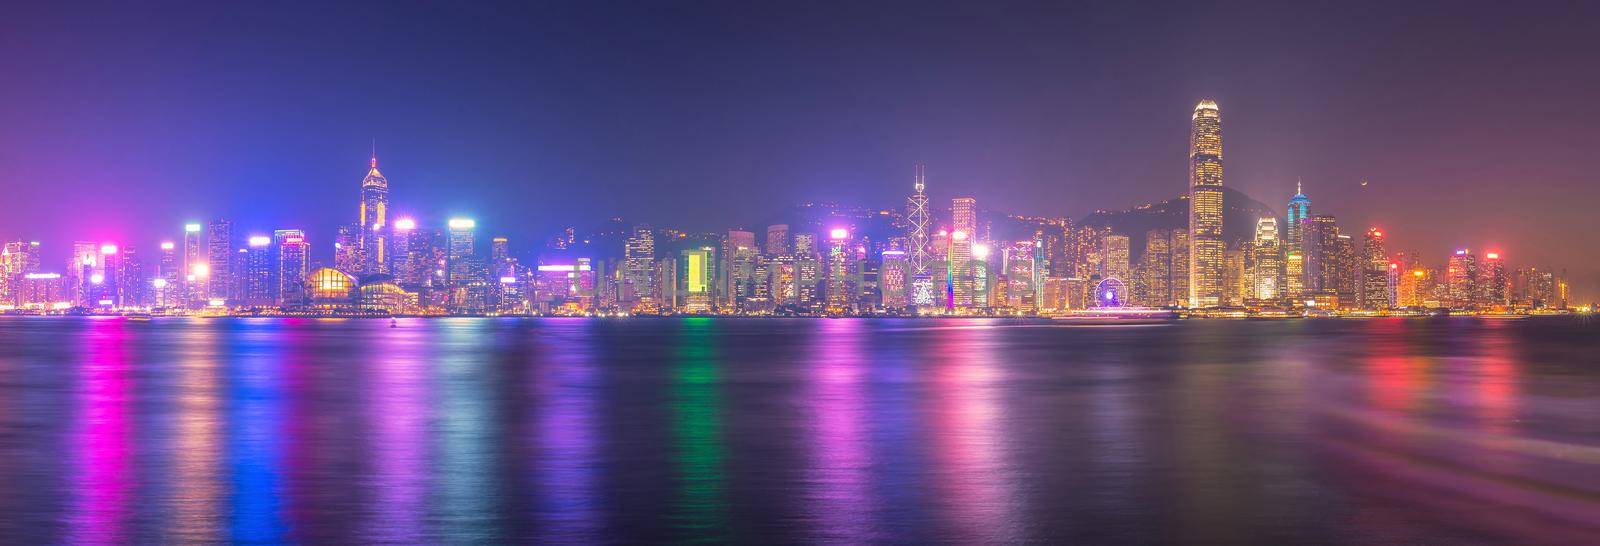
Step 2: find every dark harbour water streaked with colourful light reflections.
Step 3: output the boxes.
[0,317,1600,544]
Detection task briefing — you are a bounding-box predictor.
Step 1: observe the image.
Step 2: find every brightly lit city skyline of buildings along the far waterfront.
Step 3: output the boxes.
[0,101,1566,315]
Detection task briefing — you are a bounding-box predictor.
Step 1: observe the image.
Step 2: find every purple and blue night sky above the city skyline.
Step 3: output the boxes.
[0,2,1600,301]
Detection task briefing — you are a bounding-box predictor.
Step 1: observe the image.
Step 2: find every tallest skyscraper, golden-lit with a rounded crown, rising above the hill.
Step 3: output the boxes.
[1189,99,1224,307]
